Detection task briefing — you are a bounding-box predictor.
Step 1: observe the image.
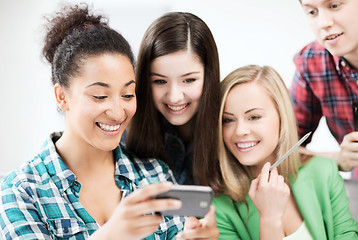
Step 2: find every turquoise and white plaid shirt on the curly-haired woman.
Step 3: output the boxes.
[0,133,185,240]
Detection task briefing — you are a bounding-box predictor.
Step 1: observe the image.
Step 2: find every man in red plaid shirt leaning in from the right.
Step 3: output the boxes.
[290,0,358,171]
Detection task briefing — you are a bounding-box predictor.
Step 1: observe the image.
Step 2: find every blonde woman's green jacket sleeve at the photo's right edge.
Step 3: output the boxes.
[328,160,358,240]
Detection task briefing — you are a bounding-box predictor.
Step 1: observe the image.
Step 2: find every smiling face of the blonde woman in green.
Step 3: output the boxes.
[222,82,280,174]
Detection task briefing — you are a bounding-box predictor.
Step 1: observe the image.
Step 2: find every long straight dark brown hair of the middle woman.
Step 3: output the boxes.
[126,12,220,188]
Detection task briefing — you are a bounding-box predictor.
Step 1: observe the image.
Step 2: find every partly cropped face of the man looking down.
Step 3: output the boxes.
[301,0,358,61]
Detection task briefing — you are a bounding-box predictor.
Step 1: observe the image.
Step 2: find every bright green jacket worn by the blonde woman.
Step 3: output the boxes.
[213,157,358,240]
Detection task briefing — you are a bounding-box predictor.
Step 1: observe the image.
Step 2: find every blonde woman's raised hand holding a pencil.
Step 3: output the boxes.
[249,162,290,221]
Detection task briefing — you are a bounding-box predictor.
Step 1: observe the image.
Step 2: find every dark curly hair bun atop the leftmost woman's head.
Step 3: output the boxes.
[42,3,107,64]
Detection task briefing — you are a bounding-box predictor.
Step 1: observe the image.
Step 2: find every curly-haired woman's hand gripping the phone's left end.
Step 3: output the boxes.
[97,182,181,239]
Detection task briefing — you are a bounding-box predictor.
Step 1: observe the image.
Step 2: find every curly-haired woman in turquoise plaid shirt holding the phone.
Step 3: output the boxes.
[0,5,219,239]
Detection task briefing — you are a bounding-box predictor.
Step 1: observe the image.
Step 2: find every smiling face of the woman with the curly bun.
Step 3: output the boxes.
[60,54,136,151]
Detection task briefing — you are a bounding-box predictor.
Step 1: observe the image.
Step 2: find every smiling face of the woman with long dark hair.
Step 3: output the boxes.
[150,51,204,126]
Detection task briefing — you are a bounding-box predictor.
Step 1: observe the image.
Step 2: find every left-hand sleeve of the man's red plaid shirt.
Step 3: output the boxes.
[289,53,322,144]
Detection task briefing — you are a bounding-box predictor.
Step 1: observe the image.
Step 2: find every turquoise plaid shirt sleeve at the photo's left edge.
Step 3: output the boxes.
[0,179,51,240]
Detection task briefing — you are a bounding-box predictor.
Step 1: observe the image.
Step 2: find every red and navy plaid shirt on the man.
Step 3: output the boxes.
[290,42,358,144]
